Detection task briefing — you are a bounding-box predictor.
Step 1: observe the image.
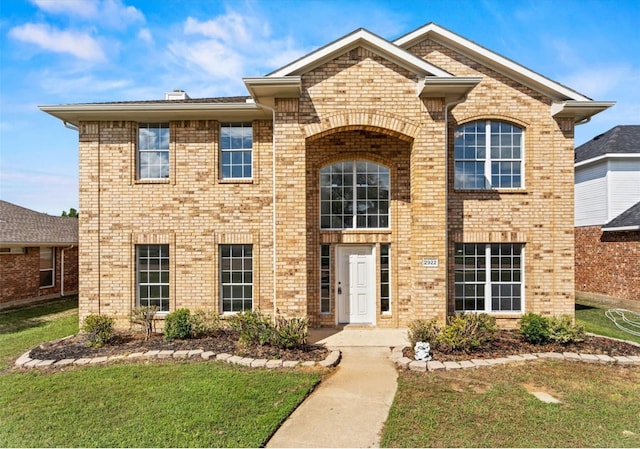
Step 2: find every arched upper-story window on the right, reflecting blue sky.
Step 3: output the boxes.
[454,120,524,189]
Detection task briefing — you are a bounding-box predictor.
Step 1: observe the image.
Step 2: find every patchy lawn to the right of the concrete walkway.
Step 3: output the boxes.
[382,361,640,447]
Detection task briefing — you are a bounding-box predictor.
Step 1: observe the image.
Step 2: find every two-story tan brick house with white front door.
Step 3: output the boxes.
[41,24,613,327]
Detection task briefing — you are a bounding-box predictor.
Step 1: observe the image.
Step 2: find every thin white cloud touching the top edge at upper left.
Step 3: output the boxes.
[32,0,145,29]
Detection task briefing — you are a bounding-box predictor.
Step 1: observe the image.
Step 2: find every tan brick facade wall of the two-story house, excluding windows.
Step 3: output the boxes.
[80,37,574,327]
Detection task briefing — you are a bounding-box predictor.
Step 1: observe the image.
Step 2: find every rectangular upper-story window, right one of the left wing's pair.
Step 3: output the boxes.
[220,123,253,179]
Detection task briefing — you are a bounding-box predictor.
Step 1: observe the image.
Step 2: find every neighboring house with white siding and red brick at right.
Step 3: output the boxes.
[575,125,640,301]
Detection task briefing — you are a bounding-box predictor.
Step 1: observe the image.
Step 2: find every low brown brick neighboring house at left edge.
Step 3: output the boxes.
[0,200,78,309]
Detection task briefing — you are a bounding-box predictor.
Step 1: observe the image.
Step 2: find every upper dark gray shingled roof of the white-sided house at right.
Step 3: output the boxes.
[575,125,640,163]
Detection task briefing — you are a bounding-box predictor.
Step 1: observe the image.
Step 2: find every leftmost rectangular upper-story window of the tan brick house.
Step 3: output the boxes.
[138,123,169,179]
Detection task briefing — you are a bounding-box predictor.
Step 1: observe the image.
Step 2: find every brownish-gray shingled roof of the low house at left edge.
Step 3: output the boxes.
[0,200,78,246]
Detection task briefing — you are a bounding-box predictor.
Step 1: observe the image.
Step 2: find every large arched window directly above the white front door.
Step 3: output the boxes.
[320,161,389,229]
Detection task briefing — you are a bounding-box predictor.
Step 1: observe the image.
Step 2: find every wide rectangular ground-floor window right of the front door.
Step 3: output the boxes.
[455,243,524,312]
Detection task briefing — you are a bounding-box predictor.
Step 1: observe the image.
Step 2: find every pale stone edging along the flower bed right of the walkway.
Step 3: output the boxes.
[391,347,640,372]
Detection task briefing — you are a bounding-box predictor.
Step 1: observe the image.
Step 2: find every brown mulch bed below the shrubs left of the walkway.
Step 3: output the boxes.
[31,332,329,362]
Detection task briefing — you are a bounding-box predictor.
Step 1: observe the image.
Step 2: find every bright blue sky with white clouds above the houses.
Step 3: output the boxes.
[0,0,640,215]
